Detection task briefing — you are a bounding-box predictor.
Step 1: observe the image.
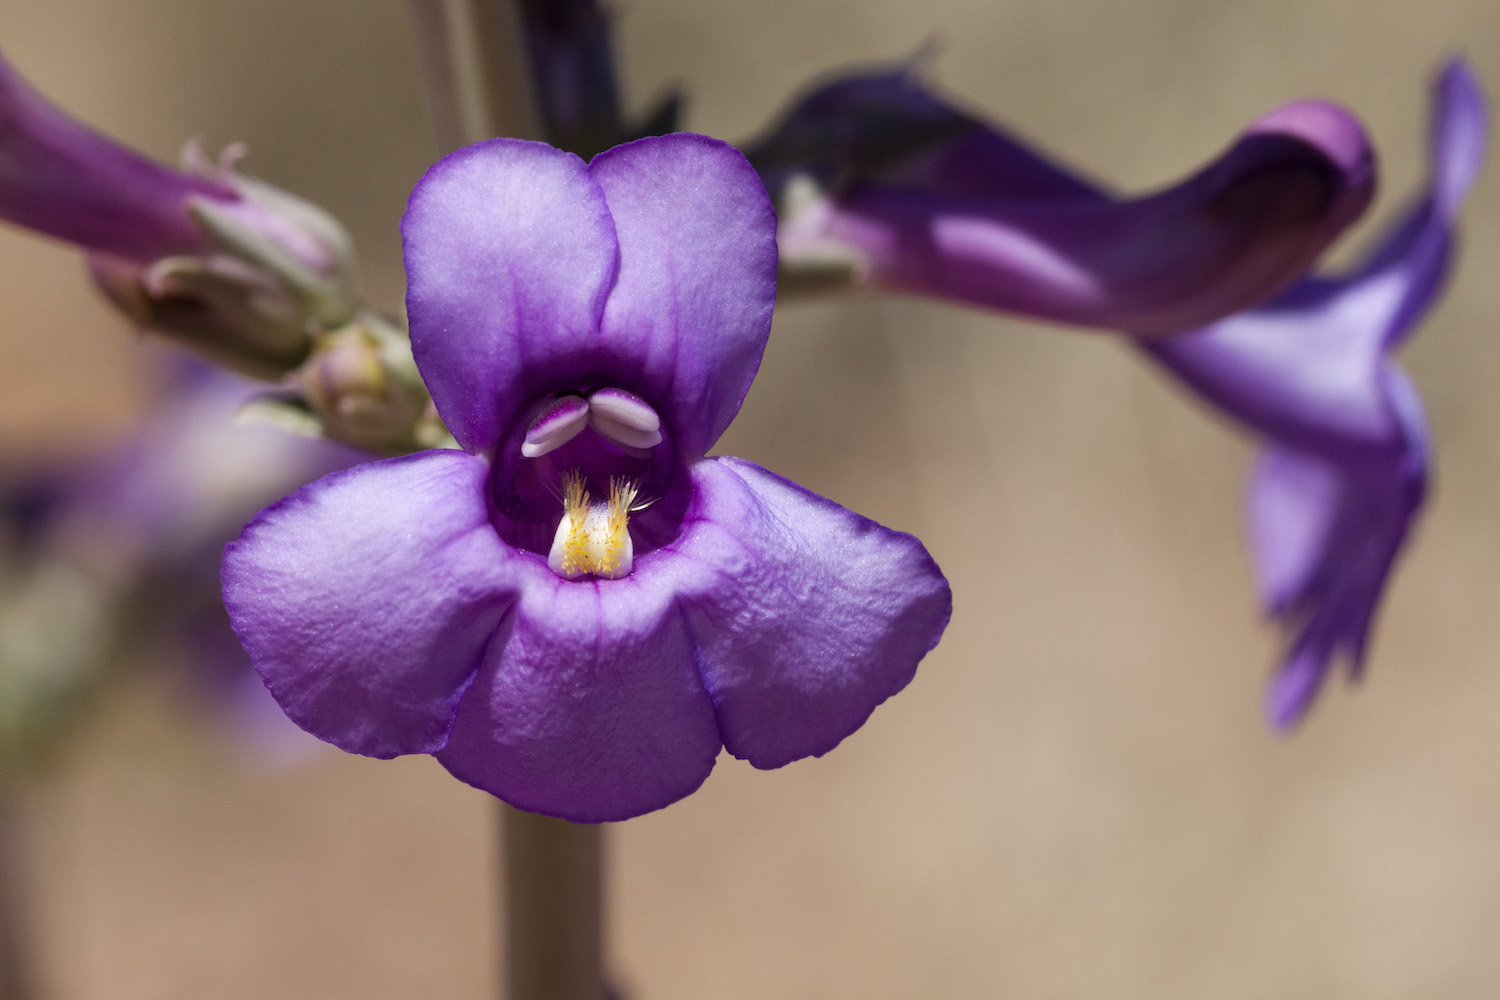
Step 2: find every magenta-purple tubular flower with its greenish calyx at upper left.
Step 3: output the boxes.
[0,47,359,378]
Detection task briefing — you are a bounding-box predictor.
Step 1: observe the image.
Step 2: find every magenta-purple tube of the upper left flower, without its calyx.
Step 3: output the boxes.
[0,49,234,261]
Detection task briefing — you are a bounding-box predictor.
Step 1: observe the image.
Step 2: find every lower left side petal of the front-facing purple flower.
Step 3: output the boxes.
[224,451,518,757]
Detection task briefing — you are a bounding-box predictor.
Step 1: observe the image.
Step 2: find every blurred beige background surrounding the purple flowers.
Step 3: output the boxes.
[0,0,1500,1000]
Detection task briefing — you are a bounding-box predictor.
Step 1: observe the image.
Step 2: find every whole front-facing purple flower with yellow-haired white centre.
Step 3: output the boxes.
[224,135,951,822]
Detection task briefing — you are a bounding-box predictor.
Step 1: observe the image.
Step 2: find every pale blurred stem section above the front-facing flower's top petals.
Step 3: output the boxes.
[408,0,546,153]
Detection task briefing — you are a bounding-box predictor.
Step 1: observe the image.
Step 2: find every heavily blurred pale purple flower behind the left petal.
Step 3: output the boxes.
[0,363,356,763]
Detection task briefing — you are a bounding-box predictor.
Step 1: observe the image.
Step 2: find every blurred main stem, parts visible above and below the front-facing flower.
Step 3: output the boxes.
[410,0,606,1000]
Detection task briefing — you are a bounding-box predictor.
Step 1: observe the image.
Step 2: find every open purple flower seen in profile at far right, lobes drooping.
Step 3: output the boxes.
[1143,60,1487,729]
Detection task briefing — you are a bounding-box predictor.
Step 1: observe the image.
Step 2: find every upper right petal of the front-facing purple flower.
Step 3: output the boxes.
[590,133,776,459]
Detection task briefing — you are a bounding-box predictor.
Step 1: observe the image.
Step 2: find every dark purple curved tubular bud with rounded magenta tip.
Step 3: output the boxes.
[749,69,1374,334]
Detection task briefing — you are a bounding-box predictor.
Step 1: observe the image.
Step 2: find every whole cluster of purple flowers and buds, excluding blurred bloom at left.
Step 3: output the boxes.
[0,21,1485,822]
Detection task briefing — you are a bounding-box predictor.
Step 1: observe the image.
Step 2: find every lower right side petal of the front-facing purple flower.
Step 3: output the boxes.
[677,457,953,768]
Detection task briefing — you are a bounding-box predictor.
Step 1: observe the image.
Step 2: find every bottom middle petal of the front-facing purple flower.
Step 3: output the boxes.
[438,556,720,823]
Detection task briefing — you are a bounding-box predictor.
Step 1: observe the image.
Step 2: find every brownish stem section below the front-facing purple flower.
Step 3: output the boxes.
[501,804,605,1000]
